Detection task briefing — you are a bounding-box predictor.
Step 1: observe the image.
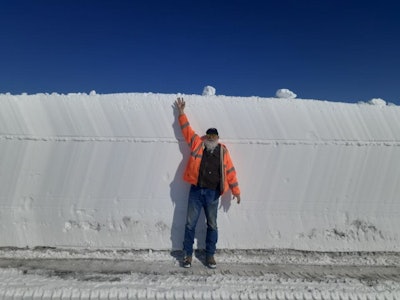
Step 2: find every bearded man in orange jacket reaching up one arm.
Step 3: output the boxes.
[175,98,240,268]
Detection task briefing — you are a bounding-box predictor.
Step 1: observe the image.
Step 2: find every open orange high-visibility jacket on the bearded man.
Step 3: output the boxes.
[179,114,240,196]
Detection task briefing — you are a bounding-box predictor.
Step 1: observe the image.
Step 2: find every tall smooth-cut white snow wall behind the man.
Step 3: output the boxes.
[0,93,400,251]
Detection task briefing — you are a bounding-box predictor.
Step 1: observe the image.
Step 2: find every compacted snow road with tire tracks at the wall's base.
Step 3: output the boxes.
[0,249,400,300]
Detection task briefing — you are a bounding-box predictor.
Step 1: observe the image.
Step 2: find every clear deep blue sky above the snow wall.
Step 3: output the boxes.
[0,0,400,105]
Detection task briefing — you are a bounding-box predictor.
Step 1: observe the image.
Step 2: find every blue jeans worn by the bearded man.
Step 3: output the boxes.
[183,185,220,256]
